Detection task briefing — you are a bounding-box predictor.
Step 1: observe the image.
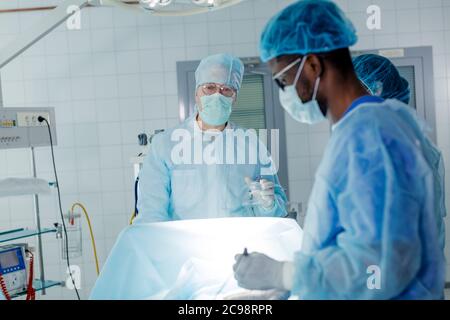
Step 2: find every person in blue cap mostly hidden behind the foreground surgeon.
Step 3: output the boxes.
[353,54,447,250]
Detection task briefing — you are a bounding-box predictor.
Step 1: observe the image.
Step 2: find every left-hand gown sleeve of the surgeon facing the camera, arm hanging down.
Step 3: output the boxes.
[134,134,171,223]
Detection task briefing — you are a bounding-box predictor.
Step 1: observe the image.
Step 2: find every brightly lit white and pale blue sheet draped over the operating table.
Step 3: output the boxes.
[90,218,302,300]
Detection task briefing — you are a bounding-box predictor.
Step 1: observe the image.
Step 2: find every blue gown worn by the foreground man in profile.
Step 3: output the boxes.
[292,100,445,299]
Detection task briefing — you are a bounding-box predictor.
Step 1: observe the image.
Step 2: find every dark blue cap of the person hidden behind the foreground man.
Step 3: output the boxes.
[353,54,411,104]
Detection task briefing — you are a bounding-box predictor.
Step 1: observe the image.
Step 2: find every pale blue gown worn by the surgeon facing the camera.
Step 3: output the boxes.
[134,114,287,223]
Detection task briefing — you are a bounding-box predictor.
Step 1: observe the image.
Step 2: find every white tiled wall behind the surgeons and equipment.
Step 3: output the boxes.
[0,0,450,299]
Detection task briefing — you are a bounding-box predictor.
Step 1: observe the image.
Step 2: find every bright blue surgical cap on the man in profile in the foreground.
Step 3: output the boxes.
[260,0,358,62]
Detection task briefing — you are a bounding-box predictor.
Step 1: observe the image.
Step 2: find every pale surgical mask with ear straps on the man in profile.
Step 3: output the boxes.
[280,56,326,125]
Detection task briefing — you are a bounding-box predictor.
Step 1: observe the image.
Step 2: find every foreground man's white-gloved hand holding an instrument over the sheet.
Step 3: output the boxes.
[233,253,293,290]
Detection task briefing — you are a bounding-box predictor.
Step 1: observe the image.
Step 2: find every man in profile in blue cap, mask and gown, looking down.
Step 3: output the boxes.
[233,0,445,299]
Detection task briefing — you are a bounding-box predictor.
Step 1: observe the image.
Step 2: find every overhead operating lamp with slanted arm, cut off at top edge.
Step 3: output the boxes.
[0,0,243,69]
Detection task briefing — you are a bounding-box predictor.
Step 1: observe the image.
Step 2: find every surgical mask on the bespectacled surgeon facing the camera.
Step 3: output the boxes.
[198,93,233,126]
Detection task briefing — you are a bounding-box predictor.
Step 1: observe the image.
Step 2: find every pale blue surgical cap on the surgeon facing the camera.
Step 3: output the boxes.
[195,54,244,91]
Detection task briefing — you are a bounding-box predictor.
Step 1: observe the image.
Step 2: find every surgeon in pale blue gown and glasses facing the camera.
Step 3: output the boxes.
[134,54,287,223]
